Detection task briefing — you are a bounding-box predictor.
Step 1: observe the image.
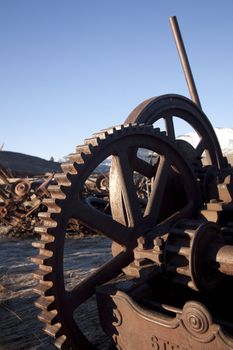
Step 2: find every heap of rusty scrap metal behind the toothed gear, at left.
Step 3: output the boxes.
[0,167,108,237]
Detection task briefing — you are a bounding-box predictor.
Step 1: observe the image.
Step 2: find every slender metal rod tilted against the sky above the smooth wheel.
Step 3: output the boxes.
[169,16,201,109]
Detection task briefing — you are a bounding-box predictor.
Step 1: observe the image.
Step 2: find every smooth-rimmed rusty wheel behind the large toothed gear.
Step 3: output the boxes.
[125,94,226,170]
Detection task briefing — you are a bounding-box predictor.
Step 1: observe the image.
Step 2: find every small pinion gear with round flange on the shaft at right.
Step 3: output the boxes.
[165,221,225,291]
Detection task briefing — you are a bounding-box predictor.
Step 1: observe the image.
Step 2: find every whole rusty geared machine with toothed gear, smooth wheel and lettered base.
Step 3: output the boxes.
[33,15,233,350]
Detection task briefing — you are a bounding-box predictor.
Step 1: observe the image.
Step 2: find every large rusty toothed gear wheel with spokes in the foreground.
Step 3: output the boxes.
[33,125,200,350]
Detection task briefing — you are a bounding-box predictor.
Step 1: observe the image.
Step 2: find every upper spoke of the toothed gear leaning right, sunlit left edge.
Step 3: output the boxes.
[144,157,171,224]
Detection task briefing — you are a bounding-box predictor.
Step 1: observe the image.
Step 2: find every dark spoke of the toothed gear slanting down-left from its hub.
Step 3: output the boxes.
[67,251,133,311]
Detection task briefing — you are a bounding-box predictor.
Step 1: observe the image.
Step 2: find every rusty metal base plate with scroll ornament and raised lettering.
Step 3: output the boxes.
[99,291,233,350]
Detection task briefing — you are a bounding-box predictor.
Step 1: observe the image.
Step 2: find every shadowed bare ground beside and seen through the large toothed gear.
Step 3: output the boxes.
[0,237,110,350]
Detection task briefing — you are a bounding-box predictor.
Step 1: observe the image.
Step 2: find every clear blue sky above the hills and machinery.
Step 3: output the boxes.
[0,0,233,159]
